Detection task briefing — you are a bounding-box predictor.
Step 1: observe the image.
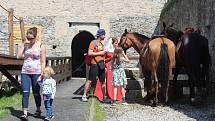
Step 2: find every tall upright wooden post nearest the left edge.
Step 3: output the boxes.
[8,8,14,56]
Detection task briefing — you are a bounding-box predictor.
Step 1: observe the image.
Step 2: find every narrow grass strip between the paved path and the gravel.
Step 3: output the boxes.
[93,98,105,121]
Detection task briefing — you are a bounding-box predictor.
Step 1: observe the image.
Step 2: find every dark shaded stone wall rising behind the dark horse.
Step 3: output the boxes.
[156,0,215,80]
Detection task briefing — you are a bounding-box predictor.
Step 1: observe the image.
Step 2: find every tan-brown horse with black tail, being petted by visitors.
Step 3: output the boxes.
[119,30,175,106]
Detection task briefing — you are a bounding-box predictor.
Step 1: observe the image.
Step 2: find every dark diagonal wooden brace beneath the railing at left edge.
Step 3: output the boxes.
[0,65,22,90]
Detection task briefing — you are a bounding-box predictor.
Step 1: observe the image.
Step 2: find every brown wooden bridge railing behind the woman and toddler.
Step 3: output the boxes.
[0,54,72,89]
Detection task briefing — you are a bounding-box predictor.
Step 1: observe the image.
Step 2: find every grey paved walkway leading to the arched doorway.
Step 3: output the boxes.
[3,79,89,121]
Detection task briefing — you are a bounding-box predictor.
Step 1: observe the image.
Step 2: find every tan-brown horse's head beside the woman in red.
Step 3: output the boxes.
[119,29,133,50]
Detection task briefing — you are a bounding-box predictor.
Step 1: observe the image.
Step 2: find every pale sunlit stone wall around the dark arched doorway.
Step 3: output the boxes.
[0,0,166,65]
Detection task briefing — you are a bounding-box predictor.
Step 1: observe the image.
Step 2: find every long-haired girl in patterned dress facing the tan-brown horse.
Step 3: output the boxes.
[112,47,129,106]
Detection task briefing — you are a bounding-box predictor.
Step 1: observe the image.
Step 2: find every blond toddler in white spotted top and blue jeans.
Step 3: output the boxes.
[42,67,56,121]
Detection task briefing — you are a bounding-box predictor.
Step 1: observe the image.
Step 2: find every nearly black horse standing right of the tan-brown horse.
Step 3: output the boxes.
[163,23,211,103]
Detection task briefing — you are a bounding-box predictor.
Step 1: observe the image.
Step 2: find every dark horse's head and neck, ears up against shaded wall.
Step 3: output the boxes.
[161,22,184,45]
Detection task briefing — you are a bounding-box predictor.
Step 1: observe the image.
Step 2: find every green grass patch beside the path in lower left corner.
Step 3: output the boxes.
[0,93,22,119]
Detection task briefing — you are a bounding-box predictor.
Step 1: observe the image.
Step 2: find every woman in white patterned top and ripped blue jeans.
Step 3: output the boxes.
[17,27,46,120]
